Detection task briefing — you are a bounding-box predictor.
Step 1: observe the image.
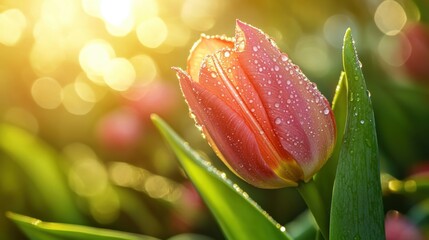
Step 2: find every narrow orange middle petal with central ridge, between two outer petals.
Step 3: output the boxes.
[199,49,303,182]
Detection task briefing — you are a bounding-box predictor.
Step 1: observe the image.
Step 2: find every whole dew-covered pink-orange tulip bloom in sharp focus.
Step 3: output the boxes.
[174,20,336,188]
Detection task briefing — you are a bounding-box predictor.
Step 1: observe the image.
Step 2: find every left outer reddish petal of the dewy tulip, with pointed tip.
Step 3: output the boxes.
[177,67,297,188]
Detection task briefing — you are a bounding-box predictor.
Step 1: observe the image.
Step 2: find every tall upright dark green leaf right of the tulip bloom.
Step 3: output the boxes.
[330,29,385,240]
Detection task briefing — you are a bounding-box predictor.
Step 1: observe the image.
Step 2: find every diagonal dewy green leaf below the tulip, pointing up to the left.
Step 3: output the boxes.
[152,115,290,240]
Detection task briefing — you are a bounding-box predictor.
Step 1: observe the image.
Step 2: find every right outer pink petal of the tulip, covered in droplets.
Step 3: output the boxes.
[235,21,335,180]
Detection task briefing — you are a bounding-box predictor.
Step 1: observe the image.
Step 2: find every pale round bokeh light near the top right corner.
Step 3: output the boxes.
[374,0,407,36]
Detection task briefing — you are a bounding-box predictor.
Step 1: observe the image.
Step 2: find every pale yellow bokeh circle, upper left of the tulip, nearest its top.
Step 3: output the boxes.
[136,17,168,48]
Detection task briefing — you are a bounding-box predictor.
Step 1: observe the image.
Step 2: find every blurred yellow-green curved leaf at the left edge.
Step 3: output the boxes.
[0,124,84,223]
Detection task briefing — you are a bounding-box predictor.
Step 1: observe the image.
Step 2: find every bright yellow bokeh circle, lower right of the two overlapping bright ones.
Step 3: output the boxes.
[103,58,136,91]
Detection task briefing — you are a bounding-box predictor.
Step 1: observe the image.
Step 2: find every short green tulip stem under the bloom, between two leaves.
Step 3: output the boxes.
[298,180,329,239]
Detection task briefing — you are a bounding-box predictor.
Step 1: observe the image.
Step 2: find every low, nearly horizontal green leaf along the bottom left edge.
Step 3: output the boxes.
[6,212,156,240]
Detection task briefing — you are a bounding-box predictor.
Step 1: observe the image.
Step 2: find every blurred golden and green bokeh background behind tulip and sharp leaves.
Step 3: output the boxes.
[0,0,429,239]
